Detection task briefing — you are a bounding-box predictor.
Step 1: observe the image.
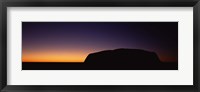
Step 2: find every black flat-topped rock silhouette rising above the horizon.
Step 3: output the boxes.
[85,49,160,64]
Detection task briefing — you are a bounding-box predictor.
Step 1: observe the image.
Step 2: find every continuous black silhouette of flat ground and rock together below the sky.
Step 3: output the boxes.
[22,49,178,70]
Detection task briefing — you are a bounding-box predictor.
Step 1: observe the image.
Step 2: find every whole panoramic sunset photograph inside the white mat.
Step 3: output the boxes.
[22,22,178,70]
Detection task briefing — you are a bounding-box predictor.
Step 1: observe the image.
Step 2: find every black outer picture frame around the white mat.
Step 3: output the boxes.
[0,0,200,92]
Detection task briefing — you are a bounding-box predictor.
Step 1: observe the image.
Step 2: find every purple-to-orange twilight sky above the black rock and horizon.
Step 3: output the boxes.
[22,22,178,62]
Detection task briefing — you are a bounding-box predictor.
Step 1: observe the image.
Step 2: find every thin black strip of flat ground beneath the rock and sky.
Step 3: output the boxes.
[22,62,178,70]
